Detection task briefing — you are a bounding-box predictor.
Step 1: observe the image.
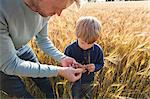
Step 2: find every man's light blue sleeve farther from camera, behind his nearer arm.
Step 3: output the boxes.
[36,24,65,62]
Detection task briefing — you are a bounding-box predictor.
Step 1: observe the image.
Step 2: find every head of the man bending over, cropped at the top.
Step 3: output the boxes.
[24,0,80,17]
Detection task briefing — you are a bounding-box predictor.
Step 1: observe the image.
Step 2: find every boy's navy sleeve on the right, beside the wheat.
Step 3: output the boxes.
[94,48,104,72]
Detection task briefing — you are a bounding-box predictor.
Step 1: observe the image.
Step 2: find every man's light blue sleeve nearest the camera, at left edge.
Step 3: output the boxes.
[0,11,58,77]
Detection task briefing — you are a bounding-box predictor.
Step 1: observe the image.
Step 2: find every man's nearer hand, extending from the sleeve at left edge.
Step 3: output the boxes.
[58,67,83,82]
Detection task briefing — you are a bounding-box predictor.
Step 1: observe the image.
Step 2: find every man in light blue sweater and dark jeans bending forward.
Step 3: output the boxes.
[0,0,83,98]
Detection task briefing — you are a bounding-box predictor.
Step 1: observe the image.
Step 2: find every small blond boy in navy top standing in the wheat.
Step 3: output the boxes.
[65,16,104,99]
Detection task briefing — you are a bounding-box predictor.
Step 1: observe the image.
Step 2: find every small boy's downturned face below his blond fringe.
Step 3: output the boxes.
[78,38,94,50]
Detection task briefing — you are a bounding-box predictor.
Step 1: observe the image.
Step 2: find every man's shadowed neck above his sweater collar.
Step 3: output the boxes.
[24,0,37,12]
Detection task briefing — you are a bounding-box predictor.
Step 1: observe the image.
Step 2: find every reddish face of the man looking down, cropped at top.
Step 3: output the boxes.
[37,0,71,17]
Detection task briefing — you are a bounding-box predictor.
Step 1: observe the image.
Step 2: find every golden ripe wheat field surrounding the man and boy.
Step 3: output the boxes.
[4,1,150,99]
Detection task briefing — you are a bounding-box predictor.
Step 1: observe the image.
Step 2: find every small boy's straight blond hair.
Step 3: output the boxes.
[76,16,101,44]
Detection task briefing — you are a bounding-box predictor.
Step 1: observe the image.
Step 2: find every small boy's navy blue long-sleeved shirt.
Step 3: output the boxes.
[65,40,104,84]
